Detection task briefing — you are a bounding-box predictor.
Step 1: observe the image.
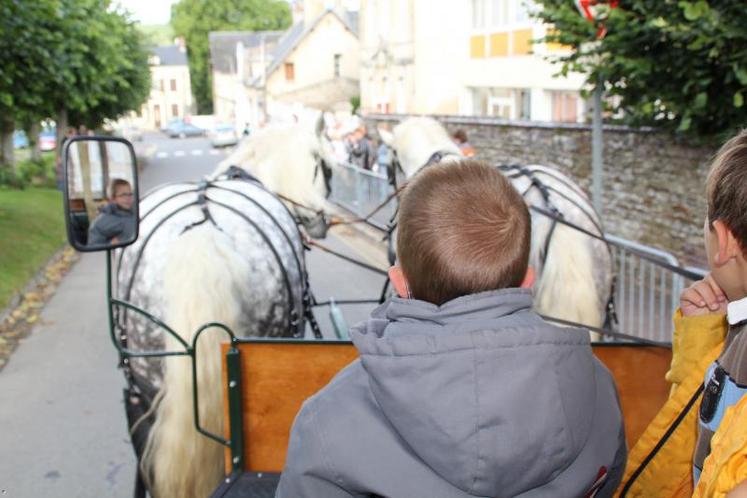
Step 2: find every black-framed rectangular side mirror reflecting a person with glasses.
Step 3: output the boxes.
[63,136,139,252]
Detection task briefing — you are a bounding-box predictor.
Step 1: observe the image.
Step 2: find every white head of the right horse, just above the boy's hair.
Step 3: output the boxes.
[377,117,462,183]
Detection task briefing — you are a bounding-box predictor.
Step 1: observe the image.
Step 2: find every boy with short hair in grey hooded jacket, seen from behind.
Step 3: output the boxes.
[277,161,626,498]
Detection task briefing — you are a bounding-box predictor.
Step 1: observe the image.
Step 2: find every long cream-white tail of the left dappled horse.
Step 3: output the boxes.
[142,224,250,498]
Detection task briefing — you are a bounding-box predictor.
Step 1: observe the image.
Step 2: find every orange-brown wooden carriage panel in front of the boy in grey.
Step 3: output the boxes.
[223,340,672,472]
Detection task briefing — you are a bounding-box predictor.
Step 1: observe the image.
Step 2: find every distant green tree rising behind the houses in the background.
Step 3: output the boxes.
[171,0,291,114]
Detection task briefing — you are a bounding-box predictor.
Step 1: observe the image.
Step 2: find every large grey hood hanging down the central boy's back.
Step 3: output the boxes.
[351,289,597,496]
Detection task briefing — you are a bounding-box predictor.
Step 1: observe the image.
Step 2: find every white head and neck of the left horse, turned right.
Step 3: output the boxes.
[212,114,336,238]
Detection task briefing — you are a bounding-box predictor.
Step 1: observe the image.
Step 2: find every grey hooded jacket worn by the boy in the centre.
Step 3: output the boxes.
[277,289,626,498]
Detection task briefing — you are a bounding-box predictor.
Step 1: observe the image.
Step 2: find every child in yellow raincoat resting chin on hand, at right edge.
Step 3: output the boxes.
[618,130,747,498]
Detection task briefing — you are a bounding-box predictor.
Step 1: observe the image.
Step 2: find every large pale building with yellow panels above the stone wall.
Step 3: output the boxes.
[360,0,586,122]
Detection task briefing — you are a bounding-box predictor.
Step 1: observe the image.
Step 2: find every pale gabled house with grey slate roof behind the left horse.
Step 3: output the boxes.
[209,0,360,129]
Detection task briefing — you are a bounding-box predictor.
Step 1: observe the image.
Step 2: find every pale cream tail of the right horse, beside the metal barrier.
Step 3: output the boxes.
[535,224,602,338]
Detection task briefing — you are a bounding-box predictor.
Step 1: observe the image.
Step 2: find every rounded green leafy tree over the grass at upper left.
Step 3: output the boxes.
[0,0,150,176]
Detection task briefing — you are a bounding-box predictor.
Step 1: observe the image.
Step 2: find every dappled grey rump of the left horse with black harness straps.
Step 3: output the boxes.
[114,180,306,387]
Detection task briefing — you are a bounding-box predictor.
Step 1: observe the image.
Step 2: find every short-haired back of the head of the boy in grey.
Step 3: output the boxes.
[397,160,531,305]
